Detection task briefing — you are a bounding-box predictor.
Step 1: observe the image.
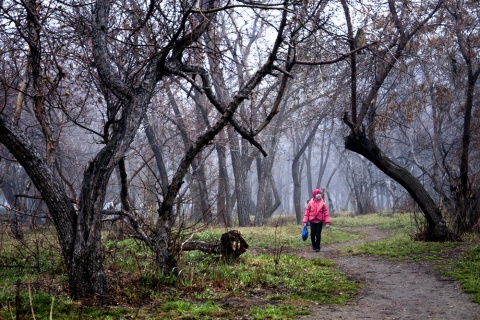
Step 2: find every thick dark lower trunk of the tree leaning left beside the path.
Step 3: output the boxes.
[344,125,459,241]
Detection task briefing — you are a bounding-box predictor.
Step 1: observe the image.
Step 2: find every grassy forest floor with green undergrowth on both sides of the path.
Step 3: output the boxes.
[0,214,480,319]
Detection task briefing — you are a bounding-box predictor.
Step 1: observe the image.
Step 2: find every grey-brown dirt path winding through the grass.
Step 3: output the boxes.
[299,228,480,320]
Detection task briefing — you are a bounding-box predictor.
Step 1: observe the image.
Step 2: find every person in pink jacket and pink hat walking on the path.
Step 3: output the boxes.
[303,189,330,252]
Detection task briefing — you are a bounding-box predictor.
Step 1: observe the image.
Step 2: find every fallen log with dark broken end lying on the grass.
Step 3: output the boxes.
[181,230,248,259]
